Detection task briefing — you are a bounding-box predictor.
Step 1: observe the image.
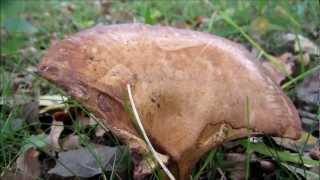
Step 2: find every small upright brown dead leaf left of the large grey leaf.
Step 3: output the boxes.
[16,148,41,180]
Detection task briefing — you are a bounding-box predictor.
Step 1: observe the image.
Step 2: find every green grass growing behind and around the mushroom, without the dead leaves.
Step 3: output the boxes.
[0,0,320,179]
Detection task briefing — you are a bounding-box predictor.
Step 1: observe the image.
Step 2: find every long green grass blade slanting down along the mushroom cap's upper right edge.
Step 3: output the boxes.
[220,12,292,79]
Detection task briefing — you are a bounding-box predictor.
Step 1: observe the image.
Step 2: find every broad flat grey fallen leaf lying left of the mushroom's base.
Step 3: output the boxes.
[48,146,124,177]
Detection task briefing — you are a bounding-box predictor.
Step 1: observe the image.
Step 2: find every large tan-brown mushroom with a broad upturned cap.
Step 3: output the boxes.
[38,24,301,179]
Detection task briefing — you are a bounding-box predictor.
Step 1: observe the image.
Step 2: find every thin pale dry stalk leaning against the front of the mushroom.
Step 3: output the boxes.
[127,84,175,180]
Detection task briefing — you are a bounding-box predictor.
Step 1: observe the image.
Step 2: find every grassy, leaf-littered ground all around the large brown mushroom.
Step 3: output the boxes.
[0,0,320,179]
